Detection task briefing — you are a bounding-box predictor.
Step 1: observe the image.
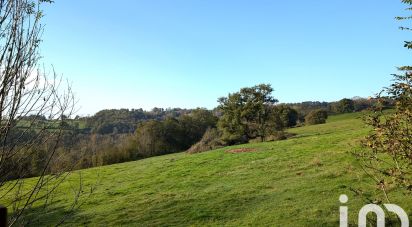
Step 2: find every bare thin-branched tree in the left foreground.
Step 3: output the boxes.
[0,0,78,225]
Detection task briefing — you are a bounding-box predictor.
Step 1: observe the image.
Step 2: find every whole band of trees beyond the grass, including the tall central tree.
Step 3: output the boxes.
[8,84,393,179]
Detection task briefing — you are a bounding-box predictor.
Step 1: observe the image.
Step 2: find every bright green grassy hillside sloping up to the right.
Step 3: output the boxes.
[4,114,412,226]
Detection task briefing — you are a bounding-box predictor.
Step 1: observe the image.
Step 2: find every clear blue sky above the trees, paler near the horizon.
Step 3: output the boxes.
[41,0,411,115]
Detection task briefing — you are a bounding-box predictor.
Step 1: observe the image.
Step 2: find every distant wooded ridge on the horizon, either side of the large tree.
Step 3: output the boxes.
[76,97,386,135]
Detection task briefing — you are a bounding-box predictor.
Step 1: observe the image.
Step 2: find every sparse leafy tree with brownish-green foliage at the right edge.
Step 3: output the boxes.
[357,0,412,202]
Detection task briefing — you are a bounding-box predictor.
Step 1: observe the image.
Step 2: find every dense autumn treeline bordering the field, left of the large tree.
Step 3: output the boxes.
[4,108,218,180]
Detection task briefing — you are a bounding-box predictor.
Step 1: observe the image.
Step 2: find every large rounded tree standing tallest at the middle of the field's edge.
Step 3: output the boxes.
[218,84,279,144]
